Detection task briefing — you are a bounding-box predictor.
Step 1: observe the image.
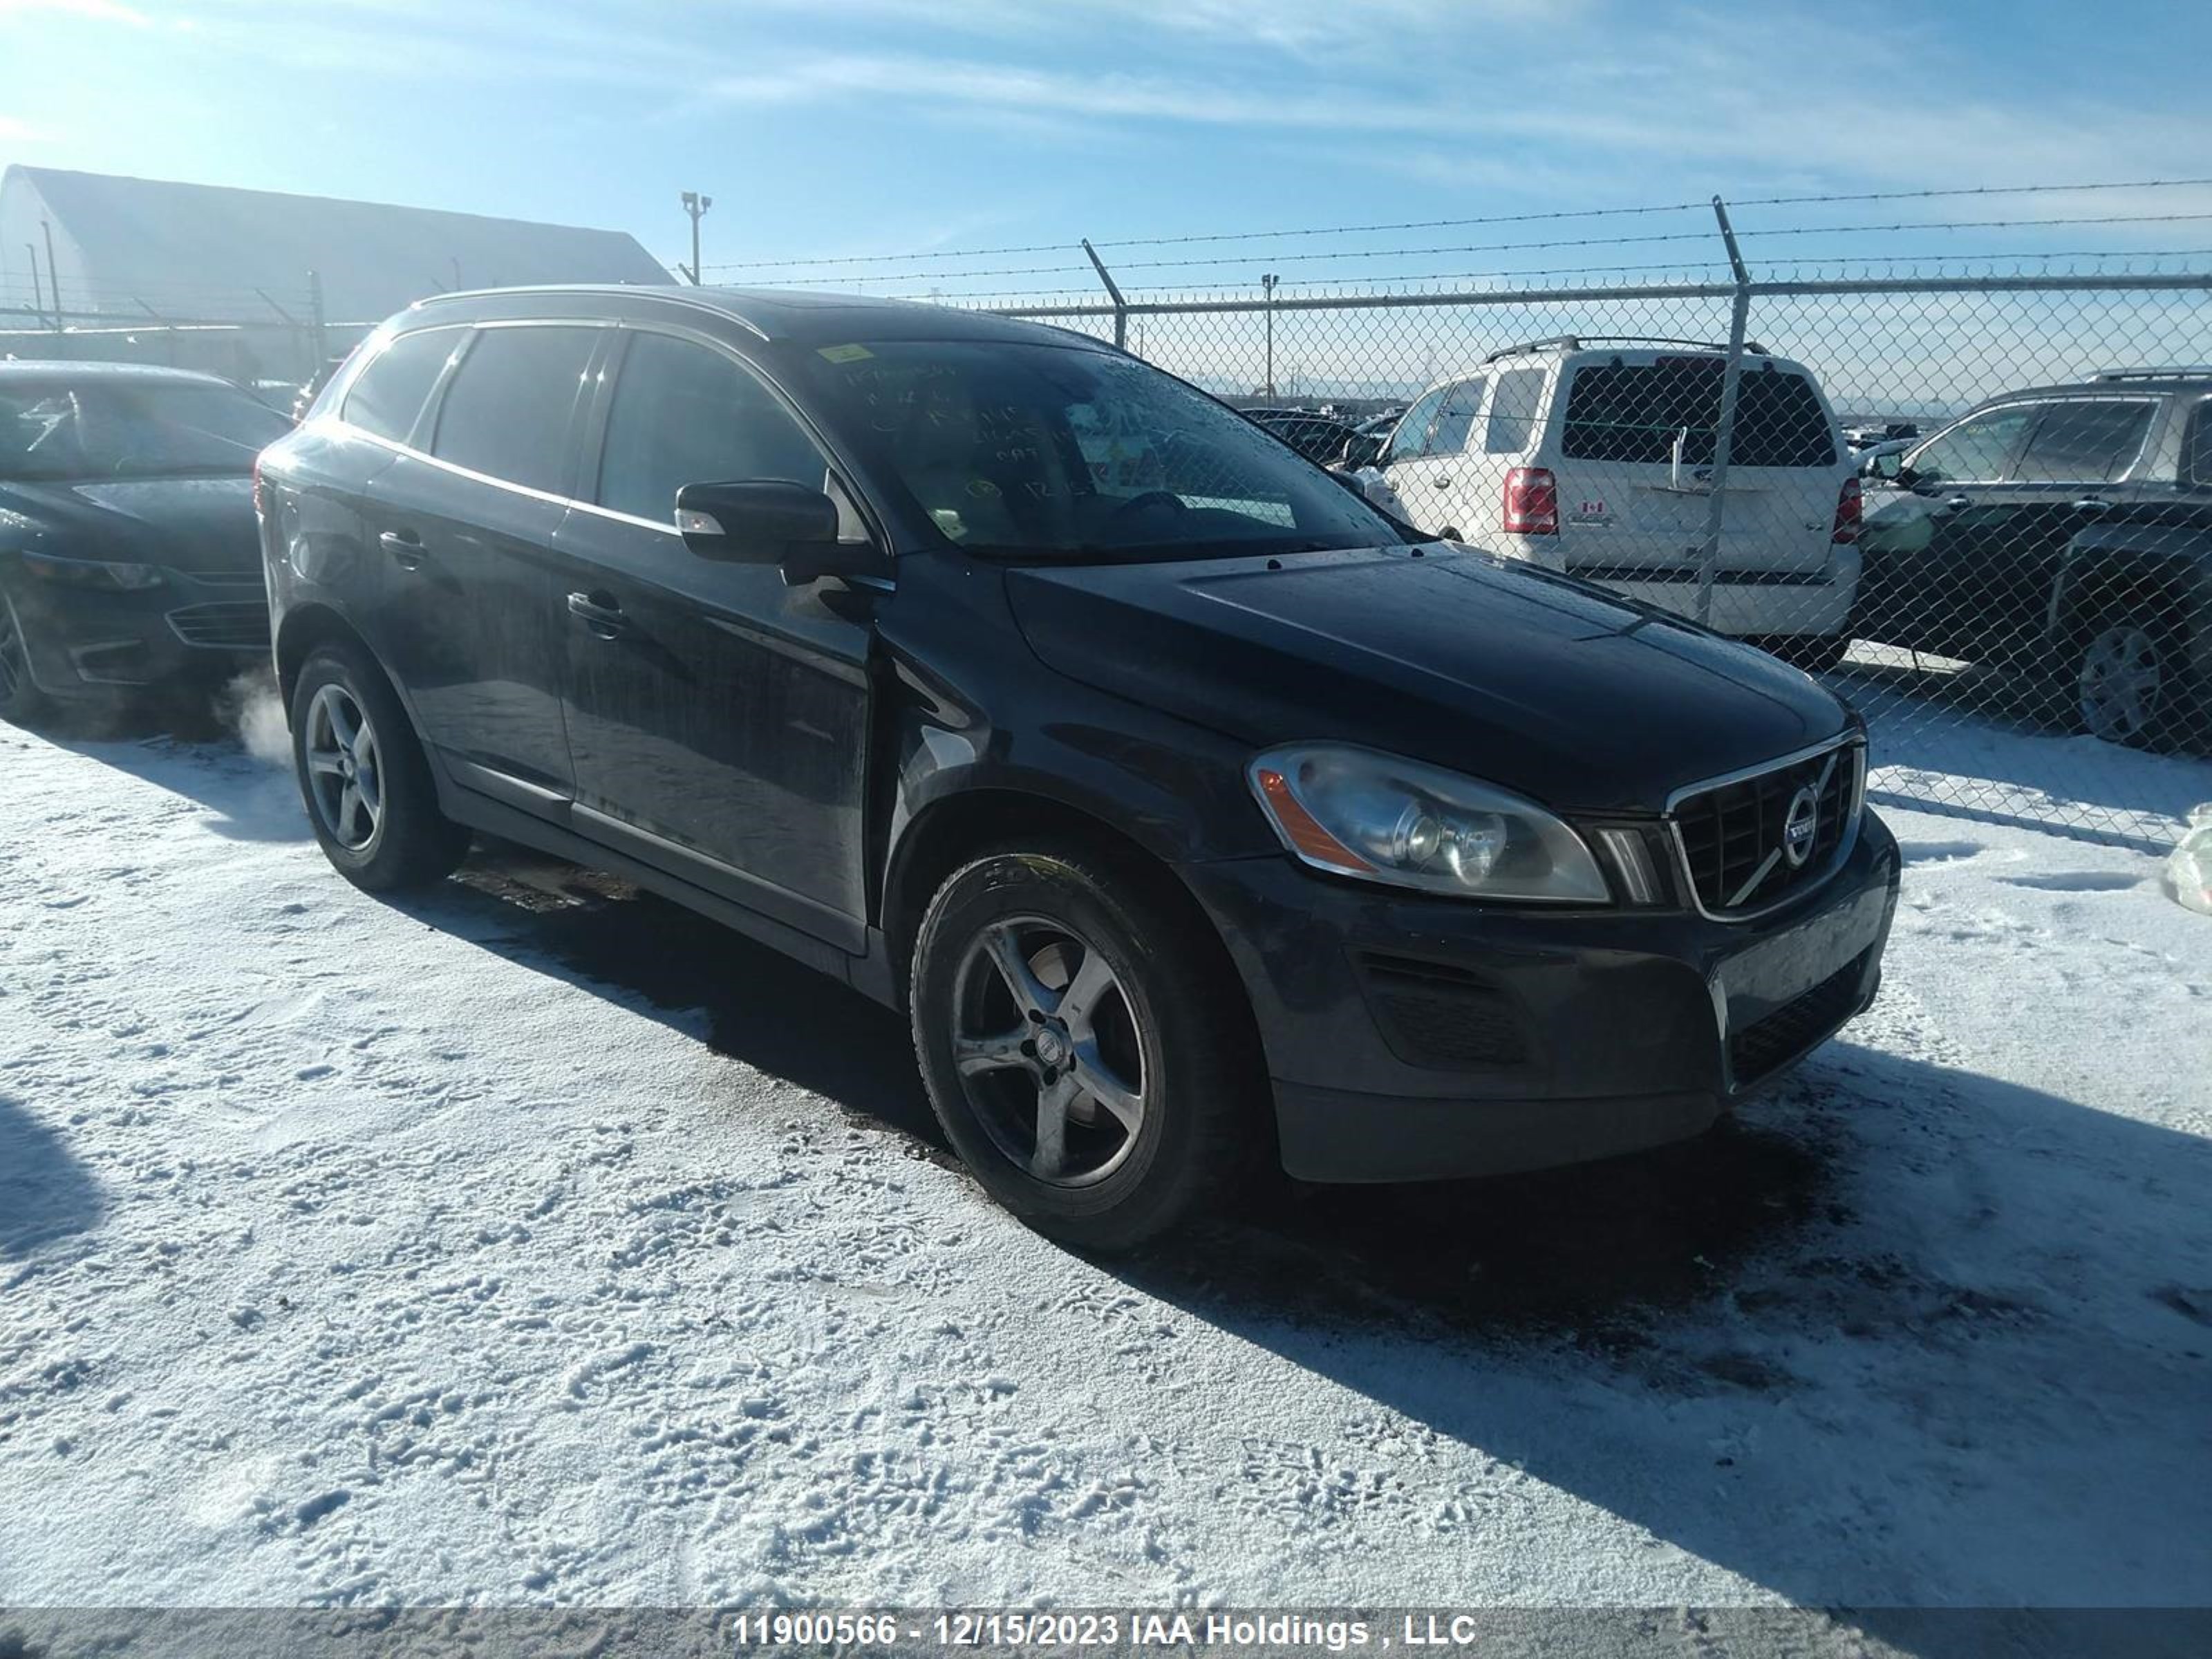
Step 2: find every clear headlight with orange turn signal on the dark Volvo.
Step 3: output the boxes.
[1246,743,1608,905]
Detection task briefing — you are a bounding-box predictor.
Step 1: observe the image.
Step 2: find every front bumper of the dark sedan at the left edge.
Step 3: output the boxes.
[9,566,270,699]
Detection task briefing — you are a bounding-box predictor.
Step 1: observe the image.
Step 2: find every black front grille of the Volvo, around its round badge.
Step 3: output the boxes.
[1668,743,1865,916]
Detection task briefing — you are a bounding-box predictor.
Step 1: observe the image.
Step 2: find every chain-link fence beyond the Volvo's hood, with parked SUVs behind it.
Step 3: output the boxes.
[907,265,2212,847]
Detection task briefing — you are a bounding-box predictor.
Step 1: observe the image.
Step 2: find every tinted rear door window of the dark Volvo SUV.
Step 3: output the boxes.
[431,328,599,496]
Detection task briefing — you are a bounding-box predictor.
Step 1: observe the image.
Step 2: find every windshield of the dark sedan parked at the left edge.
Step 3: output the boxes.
[0,380,292,478]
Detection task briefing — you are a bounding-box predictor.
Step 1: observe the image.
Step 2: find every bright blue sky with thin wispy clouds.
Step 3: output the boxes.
[0,0,2212,290]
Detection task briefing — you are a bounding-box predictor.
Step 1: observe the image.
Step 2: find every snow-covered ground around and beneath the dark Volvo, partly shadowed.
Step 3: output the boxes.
[0,708,2212,1606]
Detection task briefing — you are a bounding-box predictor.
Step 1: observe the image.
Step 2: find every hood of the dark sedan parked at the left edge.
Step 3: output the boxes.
[0,478,261,571]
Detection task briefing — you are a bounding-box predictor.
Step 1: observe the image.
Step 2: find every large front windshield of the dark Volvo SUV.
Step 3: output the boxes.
[798,341,1405,560]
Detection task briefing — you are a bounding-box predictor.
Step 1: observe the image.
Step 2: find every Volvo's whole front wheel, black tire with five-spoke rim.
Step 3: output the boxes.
[911,843,1272,1250]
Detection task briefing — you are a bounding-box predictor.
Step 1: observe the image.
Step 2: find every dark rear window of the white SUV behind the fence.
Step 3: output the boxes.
[1562,356,1836,467]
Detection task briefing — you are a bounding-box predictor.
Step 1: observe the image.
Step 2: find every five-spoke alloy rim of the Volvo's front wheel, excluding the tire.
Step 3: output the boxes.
[953,916,1146,1185]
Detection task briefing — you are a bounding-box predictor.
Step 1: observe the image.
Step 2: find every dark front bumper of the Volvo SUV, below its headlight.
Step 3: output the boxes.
[1183,812,1898,1181]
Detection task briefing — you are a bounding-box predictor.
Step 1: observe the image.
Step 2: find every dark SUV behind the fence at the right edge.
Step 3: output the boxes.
[1851,367,2212,748]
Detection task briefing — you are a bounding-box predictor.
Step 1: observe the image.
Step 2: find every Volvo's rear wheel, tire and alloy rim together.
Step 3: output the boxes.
[292,641,469,894]
